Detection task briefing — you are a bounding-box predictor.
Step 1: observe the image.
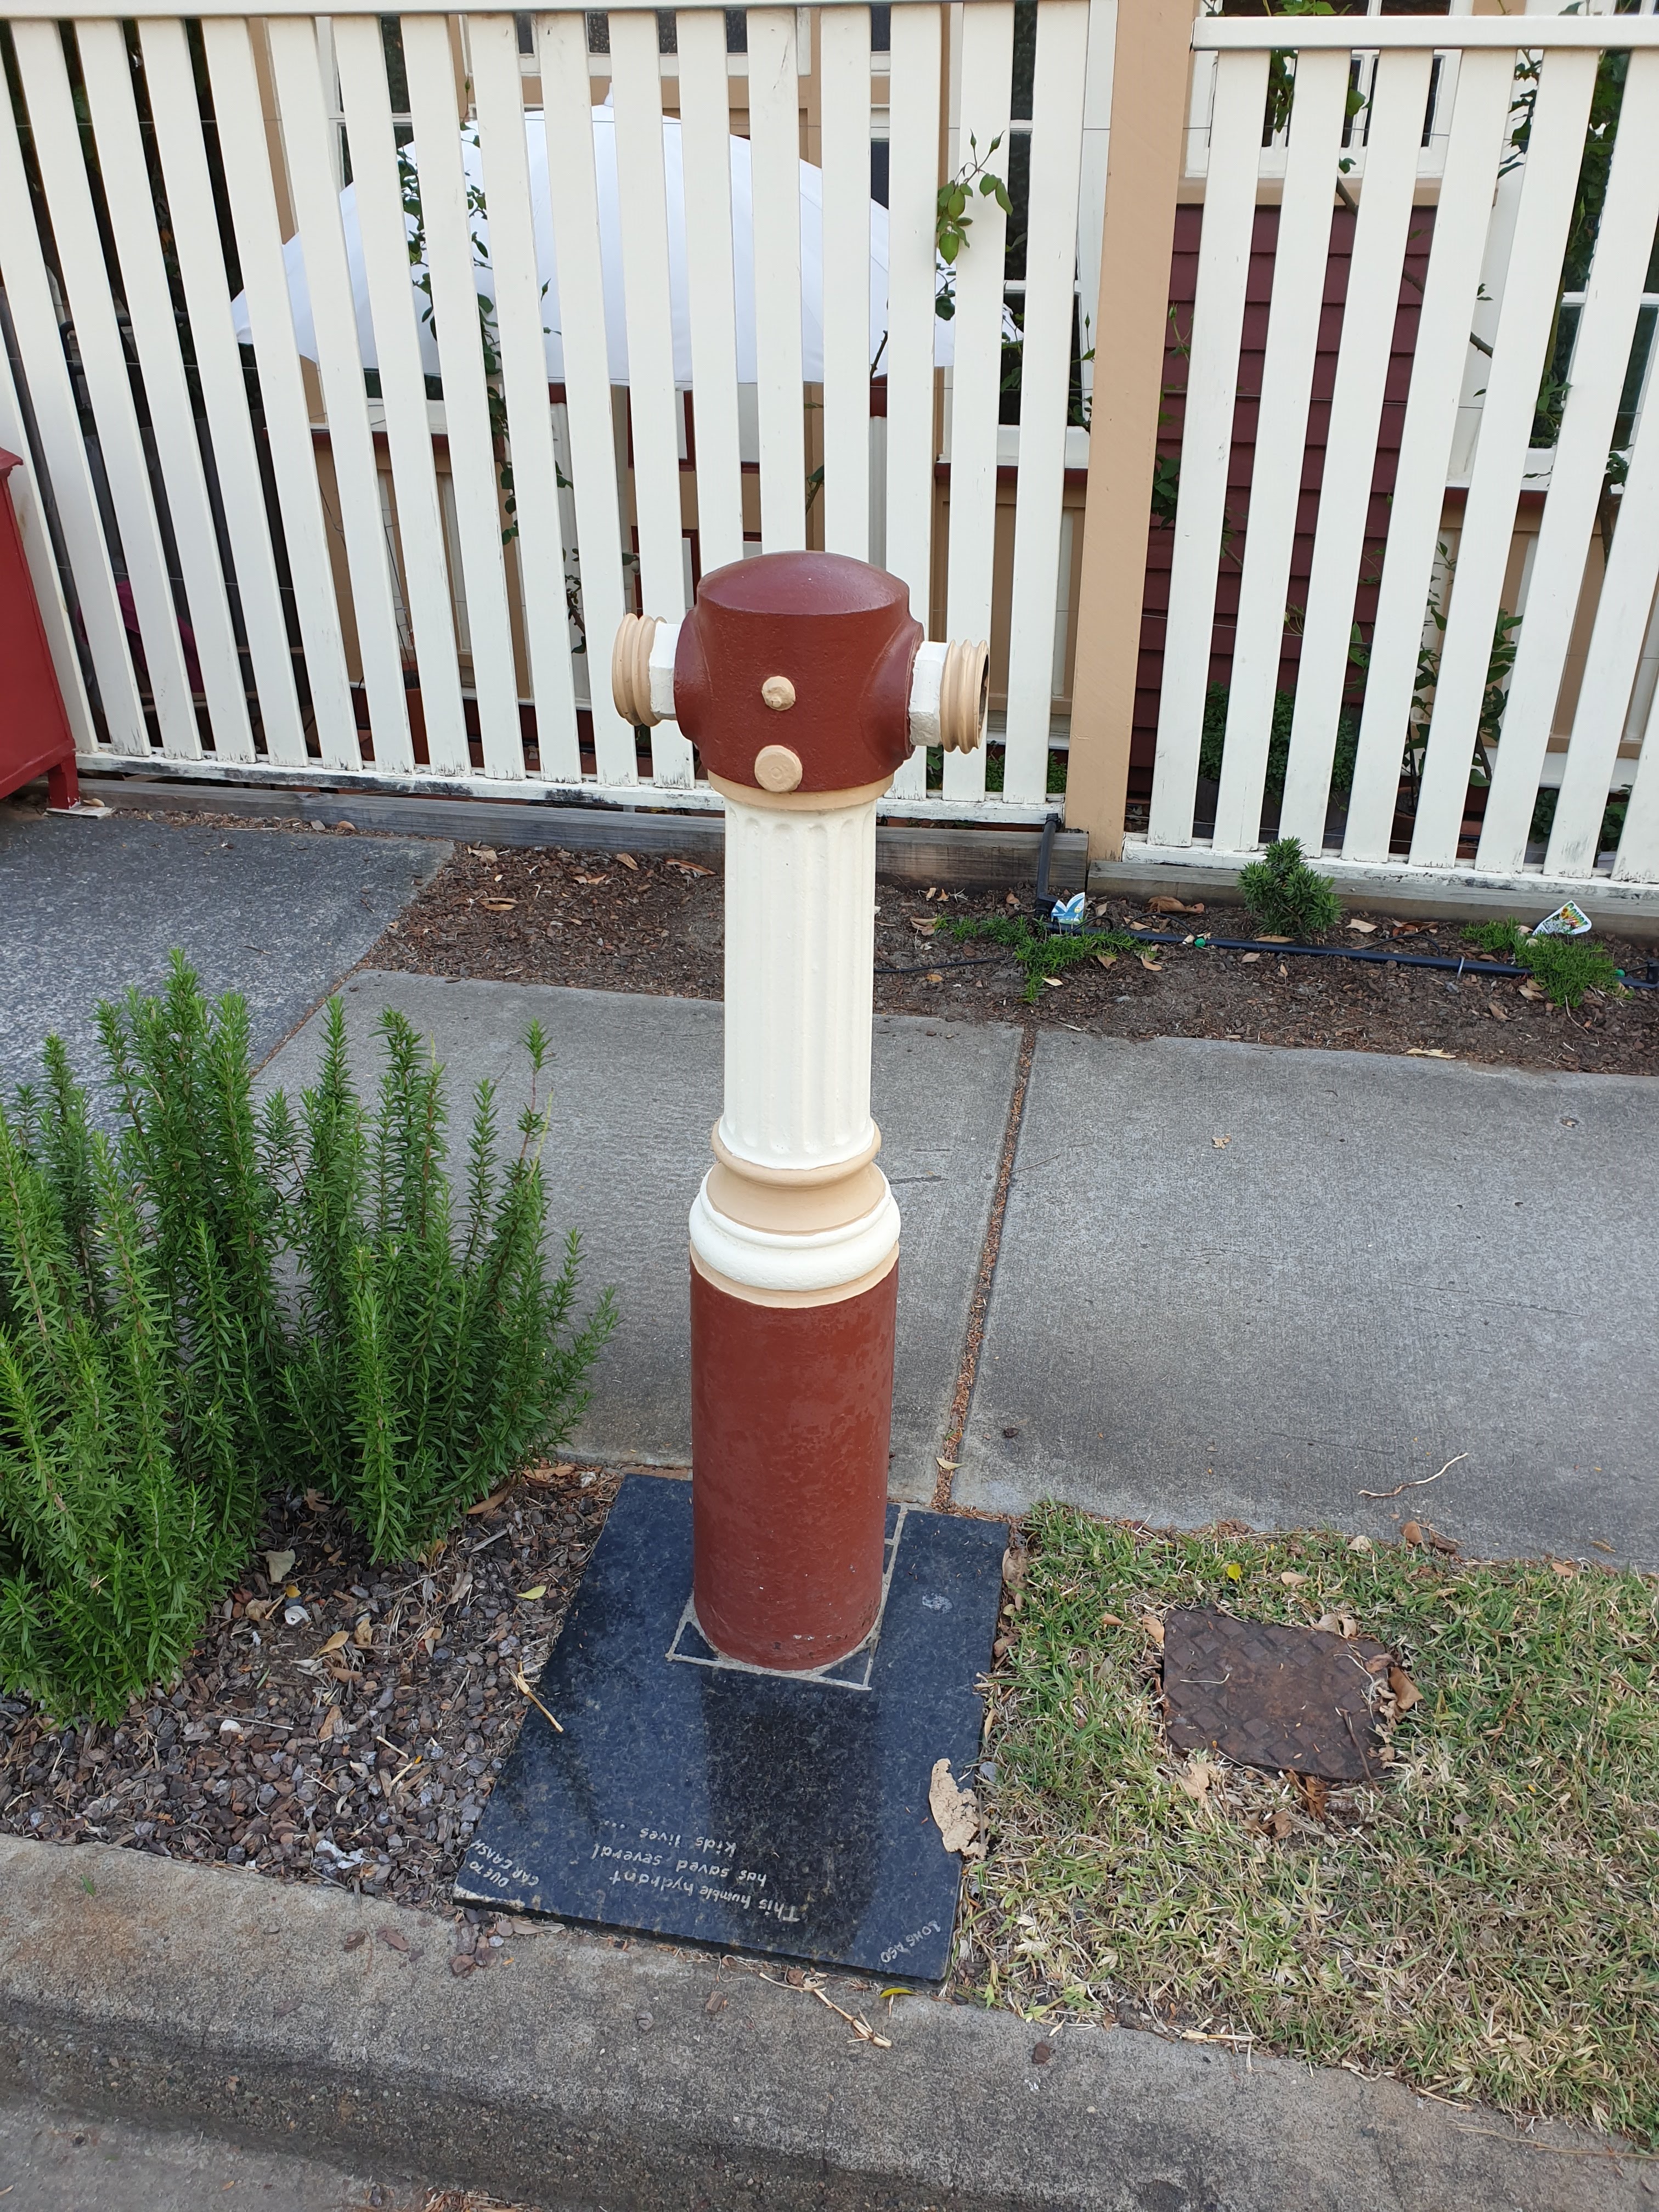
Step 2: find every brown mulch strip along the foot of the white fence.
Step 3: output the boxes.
[345,847,1659,1075]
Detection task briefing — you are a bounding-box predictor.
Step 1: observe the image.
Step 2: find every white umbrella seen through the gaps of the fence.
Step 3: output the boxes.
[230,106,953,390]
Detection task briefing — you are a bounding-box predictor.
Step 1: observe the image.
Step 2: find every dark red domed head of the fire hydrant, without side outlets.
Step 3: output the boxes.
[675,553,922,792]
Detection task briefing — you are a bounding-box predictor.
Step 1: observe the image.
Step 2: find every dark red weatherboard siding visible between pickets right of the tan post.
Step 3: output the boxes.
[1130,206,1434,768]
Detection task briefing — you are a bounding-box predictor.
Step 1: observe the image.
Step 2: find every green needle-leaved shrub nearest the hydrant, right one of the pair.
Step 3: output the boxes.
[266,1000,615,1562]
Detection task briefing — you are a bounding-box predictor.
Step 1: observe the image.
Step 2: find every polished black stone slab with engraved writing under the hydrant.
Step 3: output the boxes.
[456,1475,1007,1982]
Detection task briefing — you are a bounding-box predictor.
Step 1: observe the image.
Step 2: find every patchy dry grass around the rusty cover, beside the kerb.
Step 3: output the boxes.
[958,1506,1659,2146]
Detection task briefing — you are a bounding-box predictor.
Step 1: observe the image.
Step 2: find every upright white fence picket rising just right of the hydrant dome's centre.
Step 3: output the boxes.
[819,4,870,560]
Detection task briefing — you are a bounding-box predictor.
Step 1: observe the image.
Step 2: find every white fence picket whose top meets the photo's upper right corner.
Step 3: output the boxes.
[1477,51,1659,870]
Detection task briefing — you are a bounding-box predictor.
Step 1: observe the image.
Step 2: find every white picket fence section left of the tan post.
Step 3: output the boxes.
[0,0,1115,819]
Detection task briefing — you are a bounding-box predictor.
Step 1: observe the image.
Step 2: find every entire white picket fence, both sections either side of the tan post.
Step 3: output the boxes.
[0,0,1659,885]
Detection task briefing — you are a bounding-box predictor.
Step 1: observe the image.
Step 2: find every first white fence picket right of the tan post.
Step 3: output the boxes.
[1148,53,1267,845]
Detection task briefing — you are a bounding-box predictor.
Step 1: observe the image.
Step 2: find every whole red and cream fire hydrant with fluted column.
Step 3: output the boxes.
[611,553,986,1672]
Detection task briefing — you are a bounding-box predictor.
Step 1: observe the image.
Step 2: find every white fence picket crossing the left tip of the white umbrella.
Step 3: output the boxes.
[201,20,363,770]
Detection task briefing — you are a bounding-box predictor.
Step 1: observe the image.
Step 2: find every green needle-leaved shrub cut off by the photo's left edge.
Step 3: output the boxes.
[0,956,279,1721]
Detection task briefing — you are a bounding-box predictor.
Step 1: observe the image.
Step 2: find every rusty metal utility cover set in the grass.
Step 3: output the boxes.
[1164,1606,1389,1783]
